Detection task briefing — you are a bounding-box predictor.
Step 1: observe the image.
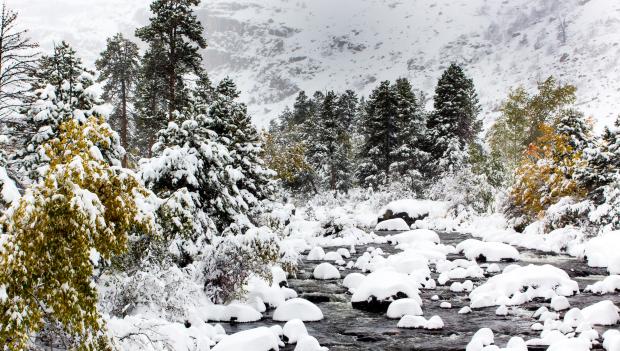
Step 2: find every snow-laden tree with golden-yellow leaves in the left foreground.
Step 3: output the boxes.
[0,117,151,351]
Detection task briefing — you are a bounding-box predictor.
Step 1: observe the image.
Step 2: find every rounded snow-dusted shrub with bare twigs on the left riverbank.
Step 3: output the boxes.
[204,227,280,303]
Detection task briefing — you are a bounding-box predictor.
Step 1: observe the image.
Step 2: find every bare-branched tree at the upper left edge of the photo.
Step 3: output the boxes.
[0,3,38,117]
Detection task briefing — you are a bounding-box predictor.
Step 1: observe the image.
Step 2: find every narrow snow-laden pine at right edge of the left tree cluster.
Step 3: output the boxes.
[209,78,274,218]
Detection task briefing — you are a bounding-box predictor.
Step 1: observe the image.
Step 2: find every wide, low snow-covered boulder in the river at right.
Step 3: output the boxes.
[469,265,579,308]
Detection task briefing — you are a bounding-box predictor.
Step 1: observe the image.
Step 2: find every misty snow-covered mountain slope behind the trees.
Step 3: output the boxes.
[9,0,620,127]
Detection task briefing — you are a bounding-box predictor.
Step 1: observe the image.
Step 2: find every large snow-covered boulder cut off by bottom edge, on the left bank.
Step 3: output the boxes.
[211,327,284,351]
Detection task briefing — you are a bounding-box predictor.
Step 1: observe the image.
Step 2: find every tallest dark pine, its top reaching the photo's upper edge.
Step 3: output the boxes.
[136,0,207,121]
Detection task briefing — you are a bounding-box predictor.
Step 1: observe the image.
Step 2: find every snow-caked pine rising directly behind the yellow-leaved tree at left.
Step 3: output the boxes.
[16,41,124,184]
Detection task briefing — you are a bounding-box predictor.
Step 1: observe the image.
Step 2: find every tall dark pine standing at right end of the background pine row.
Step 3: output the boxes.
[427,63,482,176]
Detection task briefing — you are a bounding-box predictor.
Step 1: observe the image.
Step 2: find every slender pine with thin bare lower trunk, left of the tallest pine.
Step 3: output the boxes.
[95,33,140,167]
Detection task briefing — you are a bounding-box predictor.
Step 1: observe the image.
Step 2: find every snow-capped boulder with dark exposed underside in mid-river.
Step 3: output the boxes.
[351,270,422,312]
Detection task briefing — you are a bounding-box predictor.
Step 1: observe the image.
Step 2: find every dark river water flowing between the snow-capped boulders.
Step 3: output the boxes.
[222,233,620,351]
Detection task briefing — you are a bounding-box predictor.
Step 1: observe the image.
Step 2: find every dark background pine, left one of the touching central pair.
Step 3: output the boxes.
[357,81,398,186]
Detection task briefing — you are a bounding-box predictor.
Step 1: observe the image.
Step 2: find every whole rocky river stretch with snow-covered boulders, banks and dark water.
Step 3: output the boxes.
[113,200,620,351]
